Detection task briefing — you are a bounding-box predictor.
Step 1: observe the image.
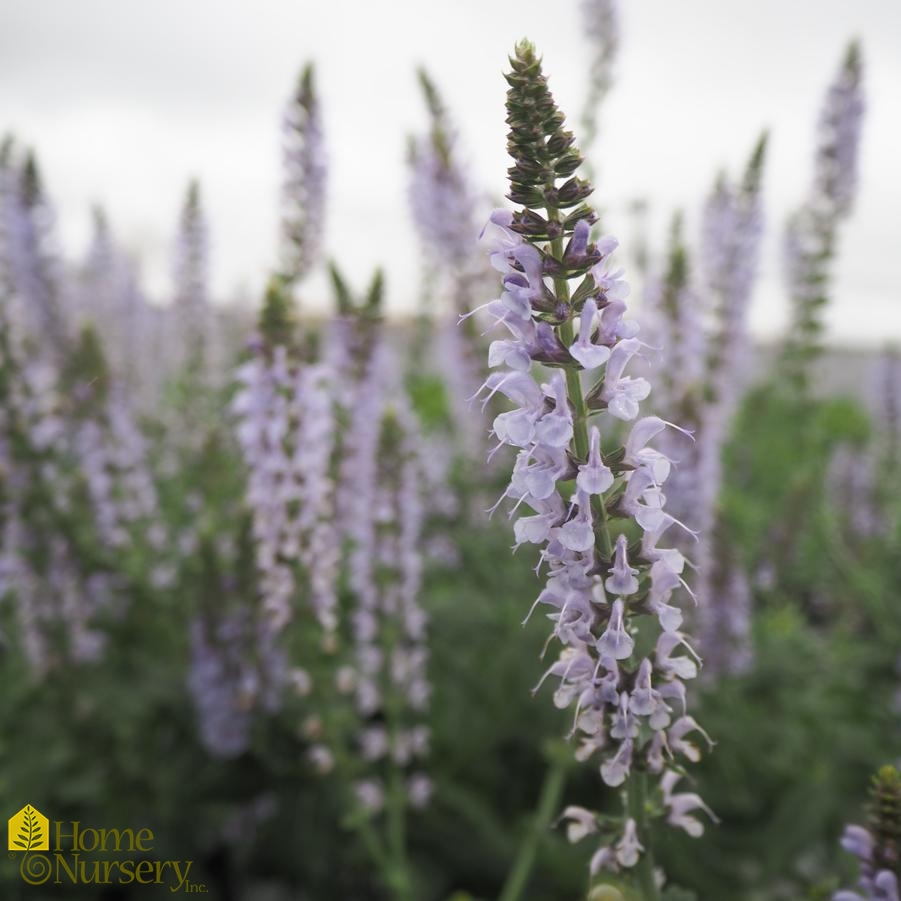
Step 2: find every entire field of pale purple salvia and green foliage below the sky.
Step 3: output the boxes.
[0,0,901,901]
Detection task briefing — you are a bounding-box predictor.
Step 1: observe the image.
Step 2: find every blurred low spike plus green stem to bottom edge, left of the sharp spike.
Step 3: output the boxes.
[348,403,432,898]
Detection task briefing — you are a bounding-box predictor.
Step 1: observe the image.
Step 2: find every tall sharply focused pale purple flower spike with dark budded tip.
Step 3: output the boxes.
[474,42,704,884]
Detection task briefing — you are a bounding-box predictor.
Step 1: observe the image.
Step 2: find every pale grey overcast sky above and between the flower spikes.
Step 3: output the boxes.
[0,0,901,342]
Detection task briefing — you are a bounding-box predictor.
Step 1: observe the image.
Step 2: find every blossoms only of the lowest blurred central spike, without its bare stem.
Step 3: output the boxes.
[349,390,431,814]
